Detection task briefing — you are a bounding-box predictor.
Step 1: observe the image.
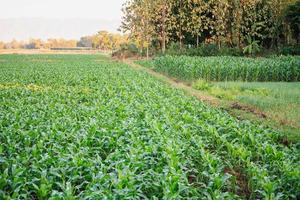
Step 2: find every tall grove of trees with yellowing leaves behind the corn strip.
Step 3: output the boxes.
[121,0,300,52]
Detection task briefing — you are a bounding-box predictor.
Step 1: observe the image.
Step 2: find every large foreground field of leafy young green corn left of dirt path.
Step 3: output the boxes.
[0,55,300,199]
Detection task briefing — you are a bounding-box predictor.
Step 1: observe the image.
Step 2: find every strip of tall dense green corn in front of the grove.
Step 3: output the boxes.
[154,56,300,81]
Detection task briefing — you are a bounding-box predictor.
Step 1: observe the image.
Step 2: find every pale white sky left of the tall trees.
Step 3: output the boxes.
[0,0,126,41]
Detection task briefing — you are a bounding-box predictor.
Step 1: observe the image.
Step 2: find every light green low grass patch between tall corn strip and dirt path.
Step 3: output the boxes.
[193,80,300,140]
